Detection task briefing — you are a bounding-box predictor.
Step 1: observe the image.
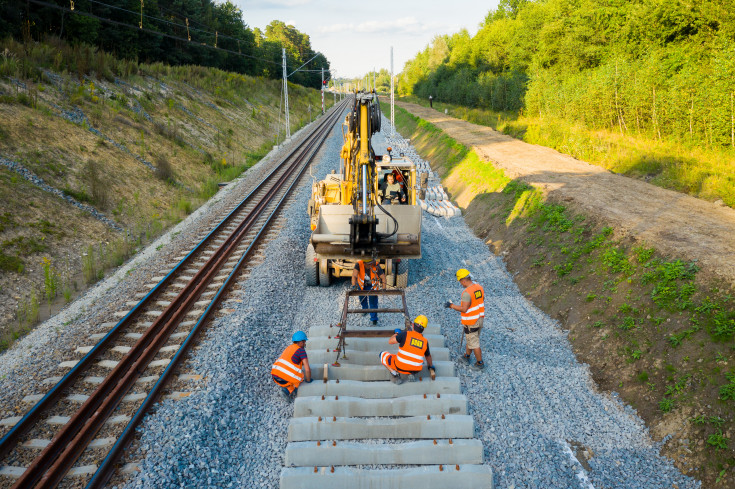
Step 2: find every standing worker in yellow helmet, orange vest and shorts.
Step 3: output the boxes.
[444,268,485,370]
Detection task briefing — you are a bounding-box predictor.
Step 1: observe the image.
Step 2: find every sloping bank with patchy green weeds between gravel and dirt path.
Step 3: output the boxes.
[396,109,735,487]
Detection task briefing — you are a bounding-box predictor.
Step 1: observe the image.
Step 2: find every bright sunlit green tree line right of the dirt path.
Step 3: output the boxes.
[398,0,735,147]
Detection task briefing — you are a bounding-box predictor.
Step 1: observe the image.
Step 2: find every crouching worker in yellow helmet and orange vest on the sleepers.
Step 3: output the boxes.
[379,315,436,384]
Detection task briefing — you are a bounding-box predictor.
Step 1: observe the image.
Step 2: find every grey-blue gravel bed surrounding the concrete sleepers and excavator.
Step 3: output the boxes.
[118,114,699,489]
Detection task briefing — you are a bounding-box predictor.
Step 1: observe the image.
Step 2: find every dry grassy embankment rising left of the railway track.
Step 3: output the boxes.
[0,40,332,352]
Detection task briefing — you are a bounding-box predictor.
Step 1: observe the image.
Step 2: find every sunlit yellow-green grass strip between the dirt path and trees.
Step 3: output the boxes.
[402,97,735,208]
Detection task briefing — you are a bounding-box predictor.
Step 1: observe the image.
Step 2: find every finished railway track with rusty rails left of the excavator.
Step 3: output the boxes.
[0,97,347,488]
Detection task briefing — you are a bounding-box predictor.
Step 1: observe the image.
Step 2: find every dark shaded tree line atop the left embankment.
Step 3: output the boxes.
[0,0,329,88]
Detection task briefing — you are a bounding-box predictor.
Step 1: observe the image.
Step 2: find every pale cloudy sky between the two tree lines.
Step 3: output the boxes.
[232,0,498,78]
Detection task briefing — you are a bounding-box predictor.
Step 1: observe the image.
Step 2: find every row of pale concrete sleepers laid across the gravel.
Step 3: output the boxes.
[280,320,492,489]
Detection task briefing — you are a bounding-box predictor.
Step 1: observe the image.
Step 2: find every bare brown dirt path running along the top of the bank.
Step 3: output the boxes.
[397,103,735,284]
